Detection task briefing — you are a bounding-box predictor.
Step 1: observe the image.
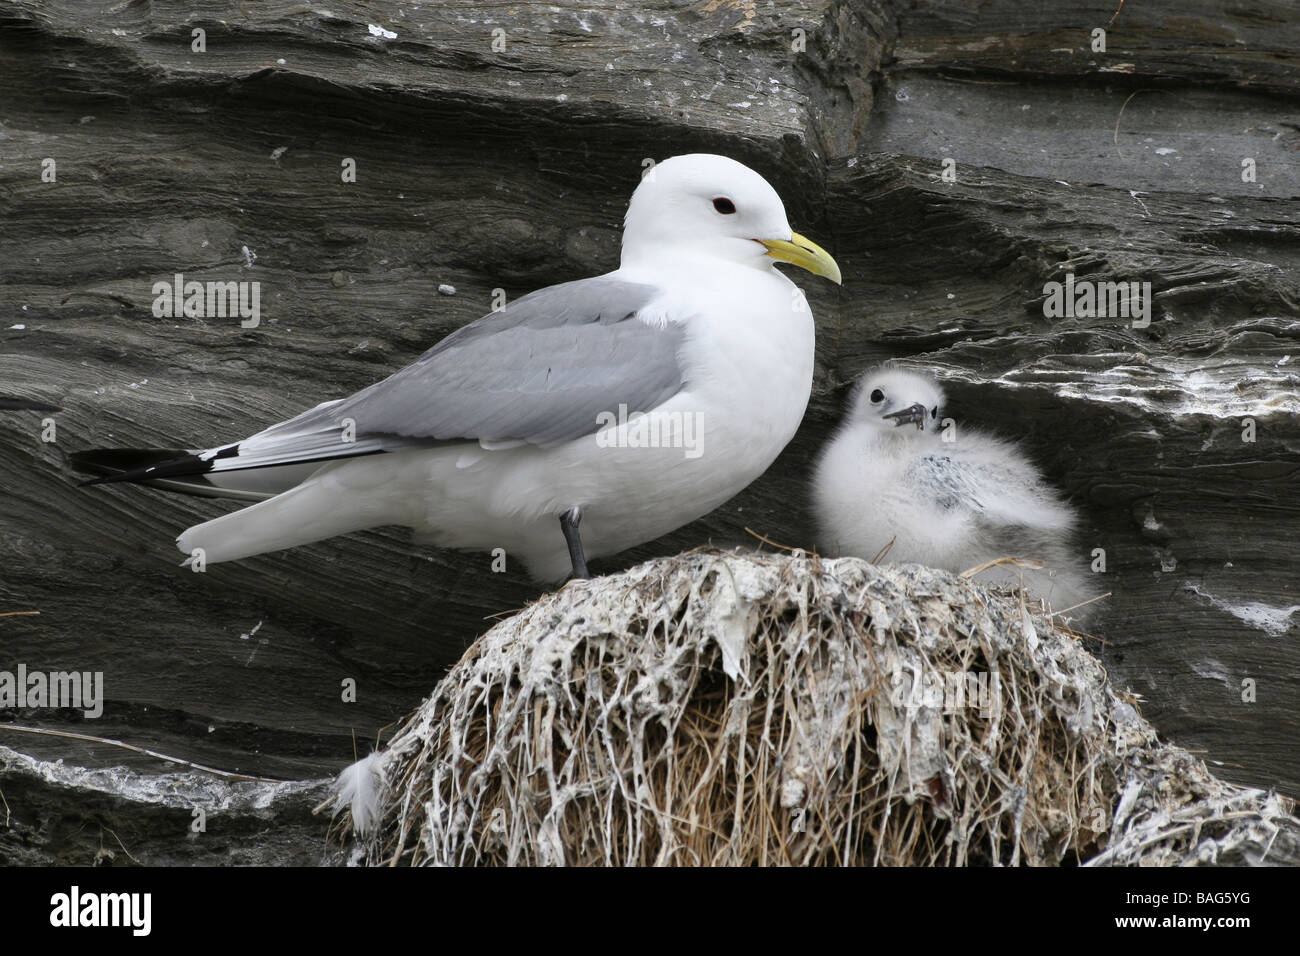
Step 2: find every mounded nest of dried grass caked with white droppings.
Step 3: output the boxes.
[330,551,1300,866]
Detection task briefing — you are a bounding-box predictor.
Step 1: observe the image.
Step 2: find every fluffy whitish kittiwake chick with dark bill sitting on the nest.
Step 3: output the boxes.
[813,365,1097,618]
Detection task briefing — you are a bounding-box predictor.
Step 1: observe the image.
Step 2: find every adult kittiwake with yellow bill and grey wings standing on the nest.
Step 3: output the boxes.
[73,153,840,580]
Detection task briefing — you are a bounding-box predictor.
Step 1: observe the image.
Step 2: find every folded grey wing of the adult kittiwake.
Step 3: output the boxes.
[205,276,684,471]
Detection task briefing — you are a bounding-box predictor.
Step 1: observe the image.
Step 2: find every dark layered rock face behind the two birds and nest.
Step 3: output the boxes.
[0,0,1300,860]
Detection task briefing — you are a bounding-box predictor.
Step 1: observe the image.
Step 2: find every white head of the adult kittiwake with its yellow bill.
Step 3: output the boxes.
[623,152,840,282]
